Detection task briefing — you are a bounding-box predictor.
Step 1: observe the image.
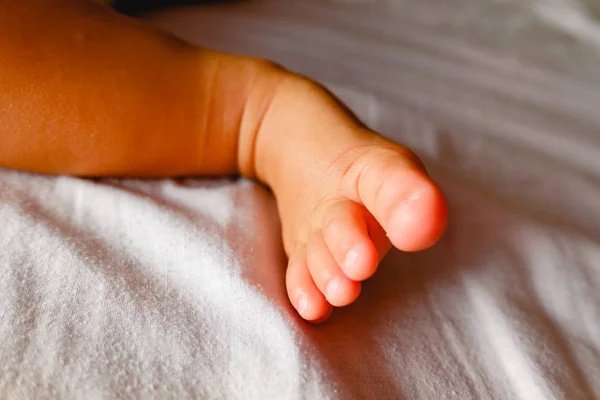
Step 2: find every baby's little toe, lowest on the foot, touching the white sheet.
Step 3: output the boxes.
[286,245,332,322]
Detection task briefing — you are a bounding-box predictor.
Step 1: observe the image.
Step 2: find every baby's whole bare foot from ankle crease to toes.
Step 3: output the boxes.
[245,71,447,322]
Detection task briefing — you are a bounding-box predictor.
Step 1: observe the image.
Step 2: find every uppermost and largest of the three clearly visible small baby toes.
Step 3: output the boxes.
[323,200,383,281]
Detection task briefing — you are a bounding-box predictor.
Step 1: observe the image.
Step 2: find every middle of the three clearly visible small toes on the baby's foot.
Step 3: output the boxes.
[306,231,360,307]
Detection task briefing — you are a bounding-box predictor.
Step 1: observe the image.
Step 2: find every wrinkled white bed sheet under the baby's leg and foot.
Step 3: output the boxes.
[0,0,600,400]
